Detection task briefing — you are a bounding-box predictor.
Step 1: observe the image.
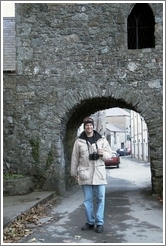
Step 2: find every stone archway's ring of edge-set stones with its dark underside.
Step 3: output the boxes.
[61,83,161,195]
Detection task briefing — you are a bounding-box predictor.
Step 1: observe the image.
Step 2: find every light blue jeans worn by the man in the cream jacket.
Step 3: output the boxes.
[82,185,105,225]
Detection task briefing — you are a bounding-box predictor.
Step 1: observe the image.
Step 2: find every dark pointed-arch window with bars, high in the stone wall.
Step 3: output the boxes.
[127,3,155,49]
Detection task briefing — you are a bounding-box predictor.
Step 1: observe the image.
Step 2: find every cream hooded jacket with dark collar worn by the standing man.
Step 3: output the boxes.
[70,131,111,185]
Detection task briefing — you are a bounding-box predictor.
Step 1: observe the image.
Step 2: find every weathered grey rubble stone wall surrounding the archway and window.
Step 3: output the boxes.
[3,3,163,193]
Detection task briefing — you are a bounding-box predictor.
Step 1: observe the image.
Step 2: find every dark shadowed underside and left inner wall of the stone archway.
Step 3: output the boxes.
[64,97,153,192]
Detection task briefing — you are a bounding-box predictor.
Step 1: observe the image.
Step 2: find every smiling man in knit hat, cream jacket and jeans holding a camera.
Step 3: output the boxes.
[71,117,111,233]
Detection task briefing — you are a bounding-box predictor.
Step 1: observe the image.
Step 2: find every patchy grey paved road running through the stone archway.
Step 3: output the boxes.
[18,156,165,245]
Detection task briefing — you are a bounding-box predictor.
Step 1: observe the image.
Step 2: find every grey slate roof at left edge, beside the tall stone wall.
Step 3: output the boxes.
[3,17,16,71]
